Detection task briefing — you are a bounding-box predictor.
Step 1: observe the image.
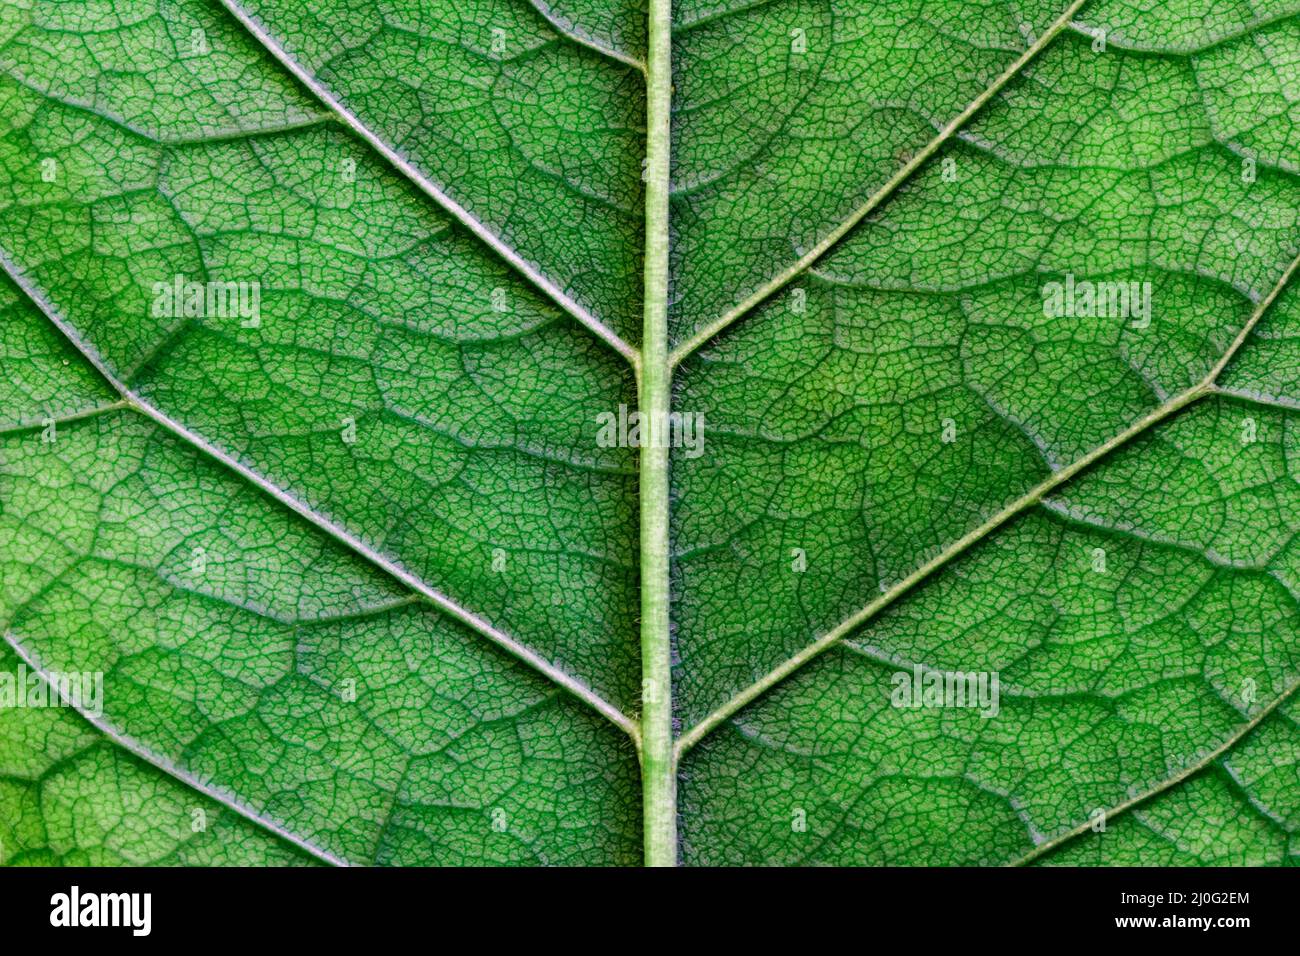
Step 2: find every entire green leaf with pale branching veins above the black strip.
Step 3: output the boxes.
[0,0,1300,865]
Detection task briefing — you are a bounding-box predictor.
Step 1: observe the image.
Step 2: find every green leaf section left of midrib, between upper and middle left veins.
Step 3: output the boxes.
[0,5,638,702]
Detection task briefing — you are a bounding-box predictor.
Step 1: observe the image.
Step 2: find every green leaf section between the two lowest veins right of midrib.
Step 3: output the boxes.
[684,401,1300,865]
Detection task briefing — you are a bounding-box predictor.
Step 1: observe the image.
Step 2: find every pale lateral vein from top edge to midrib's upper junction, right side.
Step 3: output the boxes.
[670,0,1088,367]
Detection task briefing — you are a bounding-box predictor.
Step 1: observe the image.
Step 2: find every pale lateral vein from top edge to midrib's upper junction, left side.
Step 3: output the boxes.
[221,0,638,365]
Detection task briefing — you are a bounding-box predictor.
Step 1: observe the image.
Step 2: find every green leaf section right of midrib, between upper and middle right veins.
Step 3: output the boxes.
[676,9,1300,717]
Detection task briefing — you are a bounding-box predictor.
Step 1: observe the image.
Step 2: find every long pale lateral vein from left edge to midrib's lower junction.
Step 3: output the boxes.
[0,250,640,740]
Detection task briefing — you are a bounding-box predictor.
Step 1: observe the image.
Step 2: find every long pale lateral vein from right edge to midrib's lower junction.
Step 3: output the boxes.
[676,239,1300,758]
